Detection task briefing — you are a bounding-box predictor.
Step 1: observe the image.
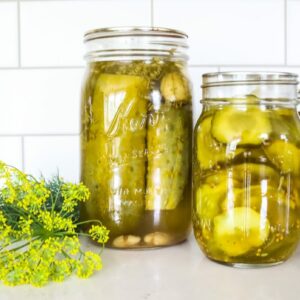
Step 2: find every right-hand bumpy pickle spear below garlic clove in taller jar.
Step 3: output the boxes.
[146,104,192,210]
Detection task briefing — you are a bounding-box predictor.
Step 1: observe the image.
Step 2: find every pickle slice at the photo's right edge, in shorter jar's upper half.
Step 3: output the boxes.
[264,140,300,174]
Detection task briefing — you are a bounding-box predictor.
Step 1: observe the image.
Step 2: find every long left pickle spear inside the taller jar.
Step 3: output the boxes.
[83,74,148,236]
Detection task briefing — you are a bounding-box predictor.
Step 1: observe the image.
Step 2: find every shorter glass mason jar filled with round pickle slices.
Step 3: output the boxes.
[193,72,300,267]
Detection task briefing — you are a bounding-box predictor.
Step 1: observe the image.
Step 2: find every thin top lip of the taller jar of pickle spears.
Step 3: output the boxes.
[84,26,188,42]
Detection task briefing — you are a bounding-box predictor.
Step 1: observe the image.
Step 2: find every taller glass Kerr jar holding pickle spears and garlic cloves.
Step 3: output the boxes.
[81,27,192,248]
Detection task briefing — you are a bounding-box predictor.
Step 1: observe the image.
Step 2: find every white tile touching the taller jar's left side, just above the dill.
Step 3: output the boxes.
[24,136,80,182]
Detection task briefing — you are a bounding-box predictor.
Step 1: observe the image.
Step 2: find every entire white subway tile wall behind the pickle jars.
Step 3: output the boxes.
[0,0,300,176]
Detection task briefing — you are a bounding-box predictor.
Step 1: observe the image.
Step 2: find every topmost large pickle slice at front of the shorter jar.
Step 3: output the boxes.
[212,105,272,145]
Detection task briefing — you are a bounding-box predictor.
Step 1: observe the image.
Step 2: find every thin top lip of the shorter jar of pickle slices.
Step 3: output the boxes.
[202,71,298,88]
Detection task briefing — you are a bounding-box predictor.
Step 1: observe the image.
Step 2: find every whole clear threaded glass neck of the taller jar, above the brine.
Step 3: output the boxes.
[84,26,188,62]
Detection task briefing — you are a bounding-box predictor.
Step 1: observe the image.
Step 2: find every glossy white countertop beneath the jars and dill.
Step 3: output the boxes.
[0,236,300,300]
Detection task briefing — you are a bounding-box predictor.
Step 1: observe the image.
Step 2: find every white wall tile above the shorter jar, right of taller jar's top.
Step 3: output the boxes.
[153,0,284,65]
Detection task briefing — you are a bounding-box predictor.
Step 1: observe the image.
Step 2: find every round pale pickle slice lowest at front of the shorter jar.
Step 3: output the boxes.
[214,207,270,256]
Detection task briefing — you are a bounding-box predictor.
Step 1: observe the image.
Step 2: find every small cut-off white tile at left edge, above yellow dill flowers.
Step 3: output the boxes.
[0,137,22,169]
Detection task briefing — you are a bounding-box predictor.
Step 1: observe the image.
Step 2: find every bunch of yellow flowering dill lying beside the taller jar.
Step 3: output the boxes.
[0,162,109,286]
